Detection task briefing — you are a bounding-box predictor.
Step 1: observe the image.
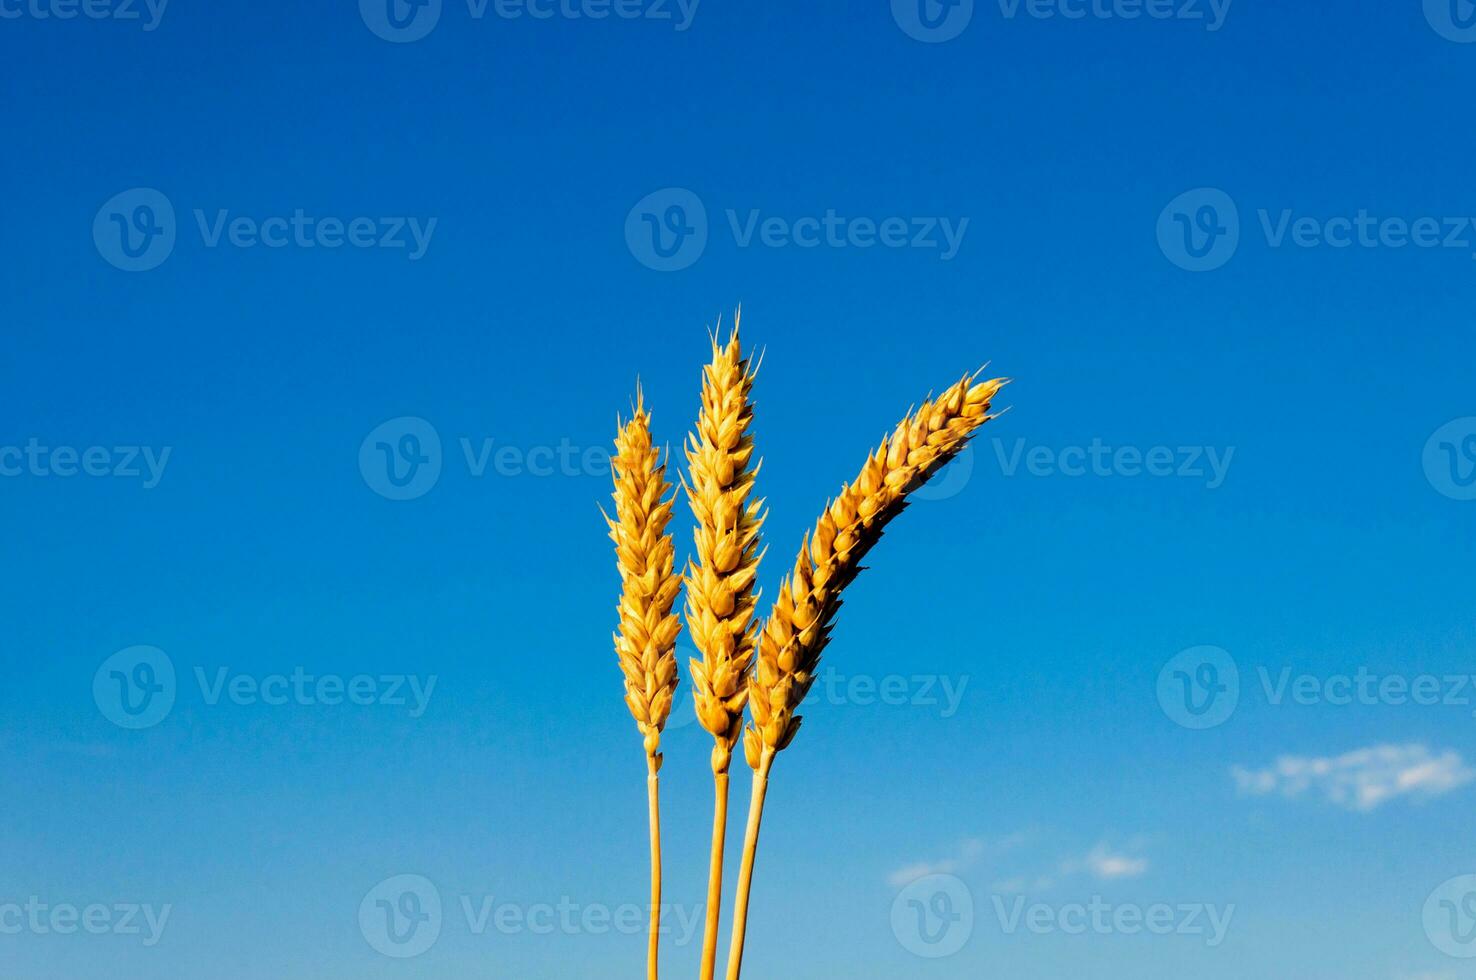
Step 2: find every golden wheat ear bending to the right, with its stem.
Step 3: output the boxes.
[728,368,1005,980]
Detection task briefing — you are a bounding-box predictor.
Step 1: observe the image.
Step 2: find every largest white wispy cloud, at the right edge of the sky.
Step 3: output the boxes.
[1231,744,1476,812]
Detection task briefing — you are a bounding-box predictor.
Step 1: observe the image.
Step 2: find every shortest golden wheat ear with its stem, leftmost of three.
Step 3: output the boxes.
[605,390,682,980]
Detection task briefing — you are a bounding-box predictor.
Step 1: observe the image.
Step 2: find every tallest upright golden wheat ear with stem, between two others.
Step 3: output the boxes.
[685,316,763,980]
